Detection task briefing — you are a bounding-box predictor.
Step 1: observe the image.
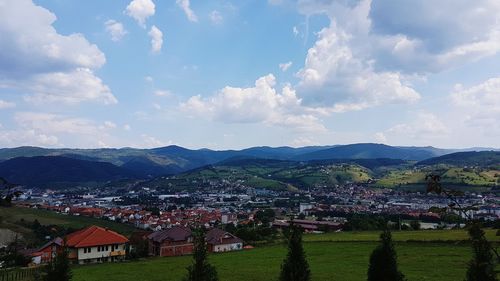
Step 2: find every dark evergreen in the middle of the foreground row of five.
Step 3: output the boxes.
[279,223,311,281]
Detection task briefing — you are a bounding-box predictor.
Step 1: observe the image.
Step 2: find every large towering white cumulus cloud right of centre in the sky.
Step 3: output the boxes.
[297,16,420,112]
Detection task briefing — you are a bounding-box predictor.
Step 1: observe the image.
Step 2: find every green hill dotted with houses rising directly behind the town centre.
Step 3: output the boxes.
[141,159,373,190]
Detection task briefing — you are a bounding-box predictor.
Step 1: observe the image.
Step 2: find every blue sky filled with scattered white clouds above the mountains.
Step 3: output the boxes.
[0,0,500,149]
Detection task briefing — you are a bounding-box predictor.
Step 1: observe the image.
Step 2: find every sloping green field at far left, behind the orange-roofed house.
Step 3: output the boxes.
[0,207,135,235]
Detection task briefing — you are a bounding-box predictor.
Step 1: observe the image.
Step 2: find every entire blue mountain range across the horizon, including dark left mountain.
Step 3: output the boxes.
[0,143,500,185]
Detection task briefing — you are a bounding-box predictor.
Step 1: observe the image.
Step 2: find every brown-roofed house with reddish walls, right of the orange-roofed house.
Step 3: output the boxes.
[148,226,193,257]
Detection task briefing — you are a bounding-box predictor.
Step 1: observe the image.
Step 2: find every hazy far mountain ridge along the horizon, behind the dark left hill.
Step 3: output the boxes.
[0,143,496,182]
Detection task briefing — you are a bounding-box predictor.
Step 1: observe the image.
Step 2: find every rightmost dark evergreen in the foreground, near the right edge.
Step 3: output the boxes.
[466,223,497,281]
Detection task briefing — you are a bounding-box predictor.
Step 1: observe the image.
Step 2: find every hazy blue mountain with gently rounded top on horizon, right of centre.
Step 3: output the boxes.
[294,143,446,161]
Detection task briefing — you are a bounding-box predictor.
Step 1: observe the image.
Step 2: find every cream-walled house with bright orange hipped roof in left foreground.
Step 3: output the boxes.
[66,225,129,264]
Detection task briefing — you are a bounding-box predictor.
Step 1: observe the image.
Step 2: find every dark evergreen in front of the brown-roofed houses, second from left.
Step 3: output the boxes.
[184,229,219,281]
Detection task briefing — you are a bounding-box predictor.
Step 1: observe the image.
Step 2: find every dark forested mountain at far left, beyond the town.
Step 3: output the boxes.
[0,156,136,186]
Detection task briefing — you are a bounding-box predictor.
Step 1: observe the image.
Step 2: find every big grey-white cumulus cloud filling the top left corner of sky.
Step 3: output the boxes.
[0,0,116,104]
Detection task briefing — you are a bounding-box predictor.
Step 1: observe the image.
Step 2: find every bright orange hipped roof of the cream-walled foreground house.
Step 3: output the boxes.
[66,225,128,248]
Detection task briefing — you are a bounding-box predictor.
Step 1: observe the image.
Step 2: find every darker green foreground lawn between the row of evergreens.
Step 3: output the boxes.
[73,242,471,281]
